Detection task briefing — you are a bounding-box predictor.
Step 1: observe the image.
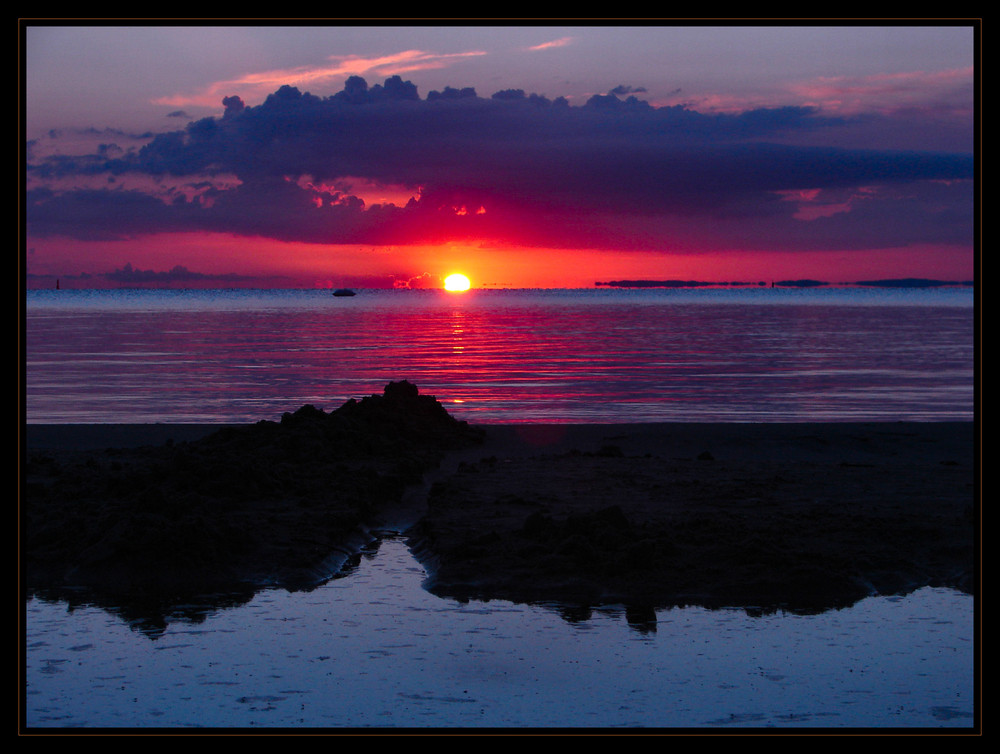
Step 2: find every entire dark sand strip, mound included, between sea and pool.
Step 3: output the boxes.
[21,382,979,621]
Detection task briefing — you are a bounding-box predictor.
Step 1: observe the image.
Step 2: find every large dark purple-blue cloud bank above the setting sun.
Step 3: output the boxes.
[26,77,974,251]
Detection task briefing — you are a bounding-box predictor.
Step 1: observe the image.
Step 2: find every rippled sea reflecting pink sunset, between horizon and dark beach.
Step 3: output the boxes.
[25,288,974,424]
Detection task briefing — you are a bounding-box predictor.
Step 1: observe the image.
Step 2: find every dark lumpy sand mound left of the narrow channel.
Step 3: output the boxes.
[22,381,480,593]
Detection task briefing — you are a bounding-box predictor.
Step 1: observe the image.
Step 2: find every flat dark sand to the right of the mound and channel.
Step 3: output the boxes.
[410,423,978,612]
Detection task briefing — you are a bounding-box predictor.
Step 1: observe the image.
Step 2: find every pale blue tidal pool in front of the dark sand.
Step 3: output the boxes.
[25,539,974,728]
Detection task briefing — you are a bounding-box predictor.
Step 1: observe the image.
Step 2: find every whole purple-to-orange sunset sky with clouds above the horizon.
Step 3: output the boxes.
[21,21,979,288]
